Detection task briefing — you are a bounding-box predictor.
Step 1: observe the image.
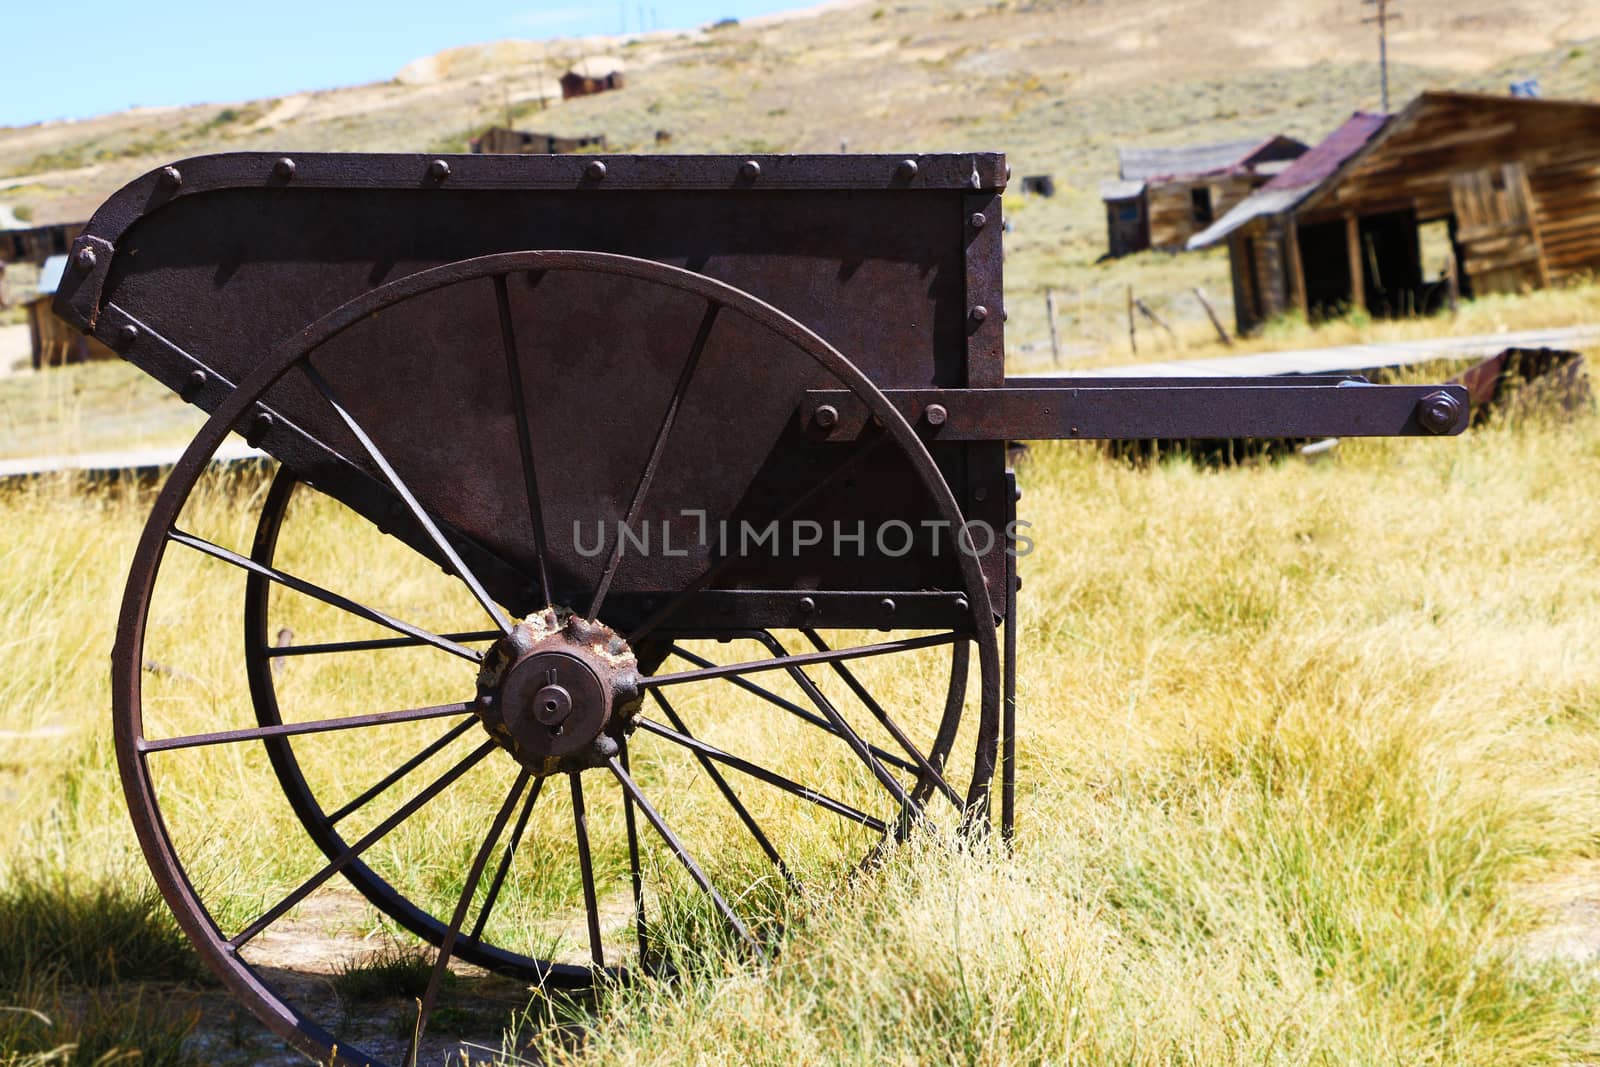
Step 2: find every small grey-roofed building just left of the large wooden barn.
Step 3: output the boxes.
[1101,134,1306,256]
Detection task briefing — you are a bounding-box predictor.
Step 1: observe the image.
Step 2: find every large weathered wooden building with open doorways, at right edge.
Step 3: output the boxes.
[1189,93,1600,331]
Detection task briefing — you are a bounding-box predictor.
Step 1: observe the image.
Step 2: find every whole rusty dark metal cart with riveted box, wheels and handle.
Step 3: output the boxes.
[56,154,1467,1064]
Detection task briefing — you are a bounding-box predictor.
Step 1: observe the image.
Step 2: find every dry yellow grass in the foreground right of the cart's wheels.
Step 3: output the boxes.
[499,421,1600,1064]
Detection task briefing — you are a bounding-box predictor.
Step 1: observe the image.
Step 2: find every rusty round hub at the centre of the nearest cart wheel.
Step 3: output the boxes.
[474,608,642,774]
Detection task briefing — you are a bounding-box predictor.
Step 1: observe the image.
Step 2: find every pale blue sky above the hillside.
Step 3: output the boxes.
[0,0,811,126]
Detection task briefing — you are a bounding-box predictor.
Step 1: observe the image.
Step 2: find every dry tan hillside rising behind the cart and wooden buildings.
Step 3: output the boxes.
[9,0,1600,364]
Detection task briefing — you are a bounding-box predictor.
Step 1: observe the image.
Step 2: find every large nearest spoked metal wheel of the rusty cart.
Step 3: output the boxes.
[114,253,1000,1064]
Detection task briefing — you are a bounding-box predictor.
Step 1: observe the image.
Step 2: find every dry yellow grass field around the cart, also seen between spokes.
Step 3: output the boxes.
[0,390,1600,1064]
